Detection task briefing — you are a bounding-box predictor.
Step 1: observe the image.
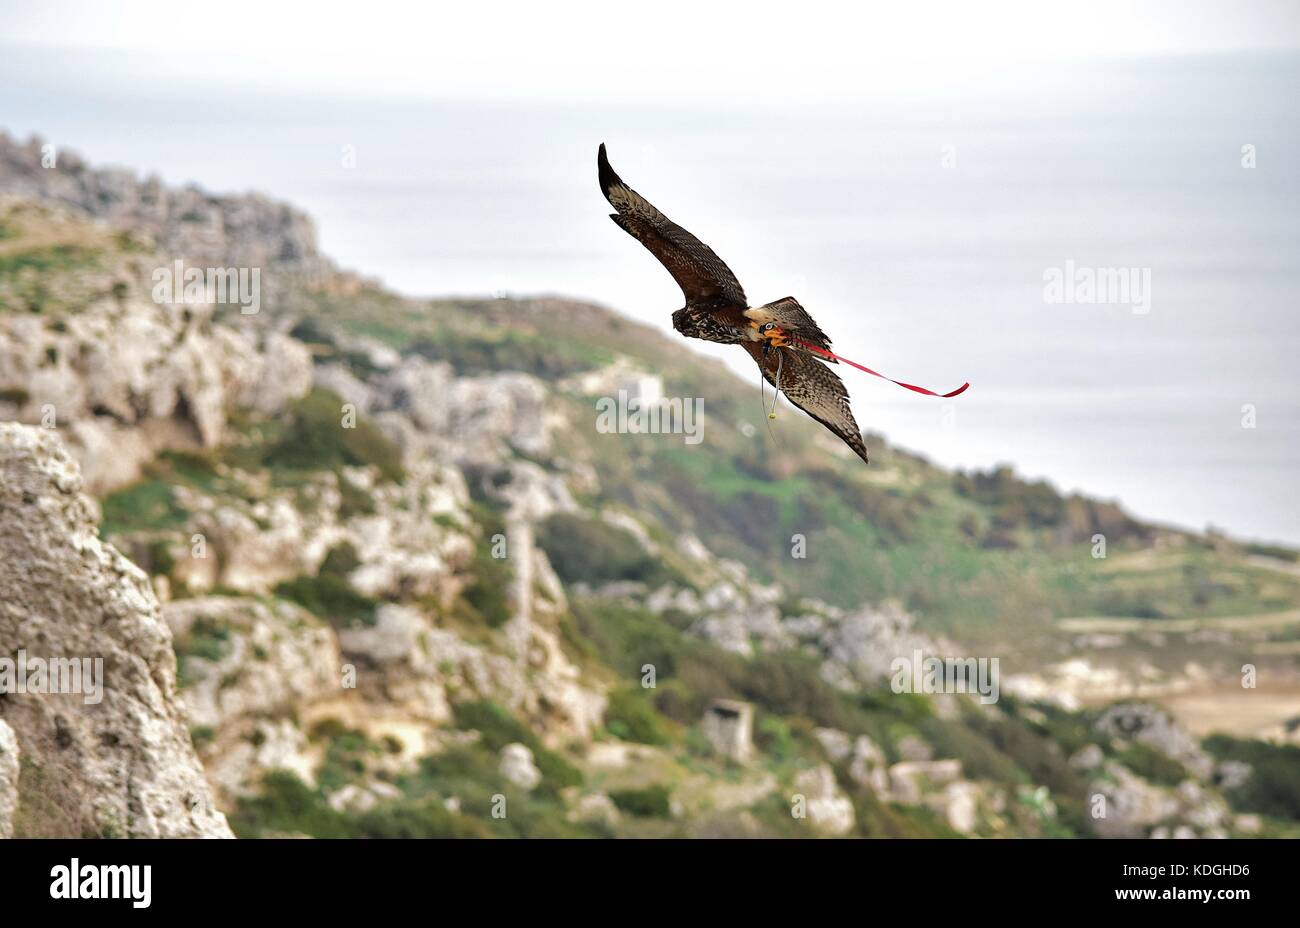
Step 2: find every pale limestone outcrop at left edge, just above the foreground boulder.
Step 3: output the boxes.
[0,239,312,494]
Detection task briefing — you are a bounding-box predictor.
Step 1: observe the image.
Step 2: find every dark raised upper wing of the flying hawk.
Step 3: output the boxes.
[597,143,749,307]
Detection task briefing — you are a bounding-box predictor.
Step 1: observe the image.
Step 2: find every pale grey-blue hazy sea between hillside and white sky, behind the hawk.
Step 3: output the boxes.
[0,48,1300,545]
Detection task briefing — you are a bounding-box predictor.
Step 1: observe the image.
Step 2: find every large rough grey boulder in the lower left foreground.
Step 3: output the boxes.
[0,424,230,837]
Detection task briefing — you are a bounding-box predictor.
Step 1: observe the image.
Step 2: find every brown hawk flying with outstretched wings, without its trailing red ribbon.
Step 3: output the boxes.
[597,143,867,461]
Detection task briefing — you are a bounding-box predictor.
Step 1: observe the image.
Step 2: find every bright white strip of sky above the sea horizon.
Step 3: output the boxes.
[0,0,1300,104]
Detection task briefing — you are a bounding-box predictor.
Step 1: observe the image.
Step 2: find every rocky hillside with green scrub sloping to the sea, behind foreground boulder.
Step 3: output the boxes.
[0,136,1300,837]
